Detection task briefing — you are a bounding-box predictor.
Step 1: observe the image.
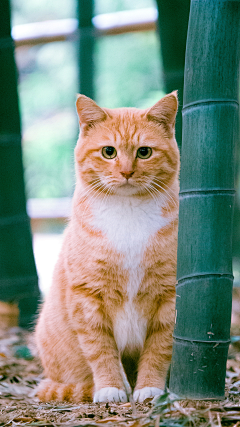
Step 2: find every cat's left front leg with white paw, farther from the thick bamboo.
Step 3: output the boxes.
[72,294,127,403]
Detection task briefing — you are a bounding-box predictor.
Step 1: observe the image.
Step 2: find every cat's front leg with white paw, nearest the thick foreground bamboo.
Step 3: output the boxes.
[133,301,174,403]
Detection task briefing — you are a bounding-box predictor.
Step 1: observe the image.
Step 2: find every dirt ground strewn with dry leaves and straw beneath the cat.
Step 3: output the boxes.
[0,290,240,427]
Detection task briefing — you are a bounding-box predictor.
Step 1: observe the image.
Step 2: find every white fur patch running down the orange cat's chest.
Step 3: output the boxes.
[89,196,169,352]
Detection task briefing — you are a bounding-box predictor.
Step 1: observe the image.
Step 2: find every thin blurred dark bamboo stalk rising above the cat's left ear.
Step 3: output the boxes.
[78,0,95,99]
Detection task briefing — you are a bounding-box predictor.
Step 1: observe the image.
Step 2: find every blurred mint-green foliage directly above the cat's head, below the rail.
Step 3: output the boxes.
[95,32,163,108]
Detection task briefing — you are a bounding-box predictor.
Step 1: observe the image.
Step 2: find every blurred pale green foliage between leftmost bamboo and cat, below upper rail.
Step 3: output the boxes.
[17,42,78,197]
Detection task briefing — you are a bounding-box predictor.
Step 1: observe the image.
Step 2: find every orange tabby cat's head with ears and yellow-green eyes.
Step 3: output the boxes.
[75,92,179,196]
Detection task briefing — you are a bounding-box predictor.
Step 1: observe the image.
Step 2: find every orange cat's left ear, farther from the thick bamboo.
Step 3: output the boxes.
[76,95,107,126]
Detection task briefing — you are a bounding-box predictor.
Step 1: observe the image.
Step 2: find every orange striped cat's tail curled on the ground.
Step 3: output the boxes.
[36,378,93,403]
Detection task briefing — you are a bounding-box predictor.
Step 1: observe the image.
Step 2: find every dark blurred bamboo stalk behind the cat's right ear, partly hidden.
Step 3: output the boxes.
[157,0,190,147]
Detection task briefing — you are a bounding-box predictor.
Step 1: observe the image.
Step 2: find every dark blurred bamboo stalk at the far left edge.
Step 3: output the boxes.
[0,0,39,327]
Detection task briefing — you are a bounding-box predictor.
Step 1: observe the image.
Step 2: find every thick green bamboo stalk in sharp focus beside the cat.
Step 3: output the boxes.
[170,0,240,399]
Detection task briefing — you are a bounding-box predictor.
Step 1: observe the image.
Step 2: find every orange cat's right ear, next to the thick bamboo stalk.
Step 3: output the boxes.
[146,90,178,128]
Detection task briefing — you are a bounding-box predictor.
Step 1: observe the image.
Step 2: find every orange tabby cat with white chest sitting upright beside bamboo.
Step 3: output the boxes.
[36,92,179,402]
